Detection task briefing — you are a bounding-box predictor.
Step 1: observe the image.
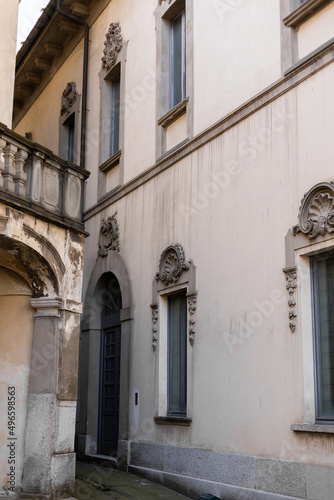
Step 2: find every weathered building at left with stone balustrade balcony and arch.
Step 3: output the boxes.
[0,1,88,498]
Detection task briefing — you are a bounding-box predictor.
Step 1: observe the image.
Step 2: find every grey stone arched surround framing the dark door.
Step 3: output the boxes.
[77,251,133,466]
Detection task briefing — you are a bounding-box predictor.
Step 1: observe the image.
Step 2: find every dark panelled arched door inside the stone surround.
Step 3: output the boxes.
[98,273,122,456]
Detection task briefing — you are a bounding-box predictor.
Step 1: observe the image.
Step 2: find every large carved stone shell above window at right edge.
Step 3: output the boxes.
[292,181,334,240]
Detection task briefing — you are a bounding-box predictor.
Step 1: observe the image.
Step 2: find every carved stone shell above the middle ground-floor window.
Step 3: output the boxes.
[156,244,190,286]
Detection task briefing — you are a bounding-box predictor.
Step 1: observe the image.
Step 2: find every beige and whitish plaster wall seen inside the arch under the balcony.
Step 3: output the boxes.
[0,267,34,493]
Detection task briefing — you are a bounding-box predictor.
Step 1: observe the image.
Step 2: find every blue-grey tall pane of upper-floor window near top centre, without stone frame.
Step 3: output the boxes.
[170,10,186,108]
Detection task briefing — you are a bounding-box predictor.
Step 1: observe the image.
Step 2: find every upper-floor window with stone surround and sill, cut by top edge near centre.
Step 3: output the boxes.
[156,0,194,158]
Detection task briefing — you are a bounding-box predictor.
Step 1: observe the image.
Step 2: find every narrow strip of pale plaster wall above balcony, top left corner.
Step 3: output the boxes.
[0,0,19,128]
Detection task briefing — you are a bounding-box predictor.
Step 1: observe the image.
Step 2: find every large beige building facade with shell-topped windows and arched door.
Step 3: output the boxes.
[5,0,334,500]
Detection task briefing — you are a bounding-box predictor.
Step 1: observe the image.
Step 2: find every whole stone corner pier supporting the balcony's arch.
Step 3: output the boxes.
[23,297,81,498]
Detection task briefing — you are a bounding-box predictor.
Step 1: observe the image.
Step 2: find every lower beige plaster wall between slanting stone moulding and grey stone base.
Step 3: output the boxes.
[86,60,334,465]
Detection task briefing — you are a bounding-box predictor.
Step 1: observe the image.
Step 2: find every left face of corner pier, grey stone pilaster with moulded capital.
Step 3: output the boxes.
[23,297,61,495]
